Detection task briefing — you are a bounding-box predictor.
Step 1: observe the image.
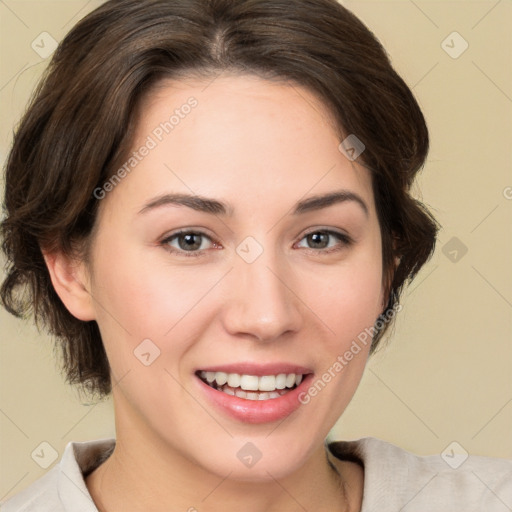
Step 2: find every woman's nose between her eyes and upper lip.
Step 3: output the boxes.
[223,244,303,342]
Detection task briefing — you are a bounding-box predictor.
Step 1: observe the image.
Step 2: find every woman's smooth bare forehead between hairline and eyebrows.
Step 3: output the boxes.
[99,75,372,220]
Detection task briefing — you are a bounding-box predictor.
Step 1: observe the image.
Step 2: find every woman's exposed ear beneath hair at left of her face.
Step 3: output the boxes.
[42,250,96,321]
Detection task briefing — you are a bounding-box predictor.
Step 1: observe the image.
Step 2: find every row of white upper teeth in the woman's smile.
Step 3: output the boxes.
[201,371,302,391]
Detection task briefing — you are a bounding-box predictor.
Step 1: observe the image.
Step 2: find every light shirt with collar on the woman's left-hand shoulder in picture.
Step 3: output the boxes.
[0,439,115,512]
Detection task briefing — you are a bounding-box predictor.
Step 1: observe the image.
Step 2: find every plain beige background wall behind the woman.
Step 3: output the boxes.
[0,0,512,500]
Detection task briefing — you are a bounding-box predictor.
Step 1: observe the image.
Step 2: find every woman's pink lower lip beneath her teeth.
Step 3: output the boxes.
[195,373,313,423]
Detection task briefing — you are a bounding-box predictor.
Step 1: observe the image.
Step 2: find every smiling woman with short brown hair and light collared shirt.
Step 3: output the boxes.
[2,0,512,512]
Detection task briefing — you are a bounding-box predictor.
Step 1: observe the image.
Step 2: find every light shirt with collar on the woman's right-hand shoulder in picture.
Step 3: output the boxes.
[328,437,512,512]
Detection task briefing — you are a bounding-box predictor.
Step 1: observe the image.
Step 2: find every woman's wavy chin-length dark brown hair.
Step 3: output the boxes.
[1,0,438,394]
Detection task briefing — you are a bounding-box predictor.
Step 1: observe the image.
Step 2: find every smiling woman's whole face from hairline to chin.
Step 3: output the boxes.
[81,76,384,480]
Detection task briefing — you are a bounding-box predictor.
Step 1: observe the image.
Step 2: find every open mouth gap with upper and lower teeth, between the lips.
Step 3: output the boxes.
[196,370,305,400]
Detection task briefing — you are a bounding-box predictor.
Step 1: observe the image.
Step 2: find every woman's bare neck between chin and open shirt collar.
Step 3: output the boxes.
[86,400,362,512]
